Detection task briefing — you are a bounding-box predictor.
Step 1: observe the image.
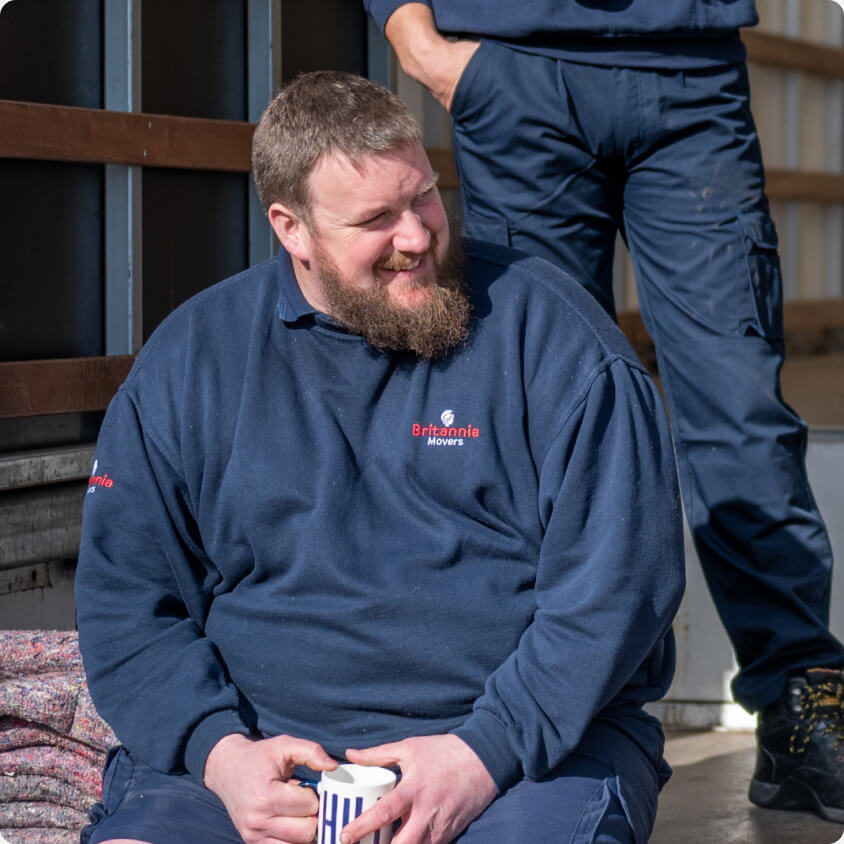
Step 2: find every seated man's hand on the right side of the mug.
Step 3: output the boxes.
[340,735,496,844]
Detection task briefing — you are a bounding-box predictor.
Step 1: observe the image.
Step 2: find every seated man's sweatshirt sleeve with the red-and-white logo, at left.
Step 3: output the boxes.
[76,387,250,783]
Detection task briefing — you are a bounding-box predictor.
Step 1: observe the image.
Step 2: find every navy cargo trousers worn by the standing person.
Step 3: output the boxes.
[452,41,844,711]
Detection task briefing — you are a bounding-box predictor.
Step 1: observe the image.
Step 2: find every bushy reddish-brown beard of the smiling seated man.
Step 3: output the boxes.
[315,238,471,359]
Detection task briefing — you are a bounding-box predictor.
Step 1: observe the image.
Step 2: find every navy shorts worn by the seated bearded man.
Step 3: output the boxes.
[81,723,667,844]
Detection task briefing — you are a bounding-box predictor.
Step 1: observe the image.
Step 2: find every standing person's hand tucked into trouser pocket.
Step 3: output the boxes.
[384,3,480,111]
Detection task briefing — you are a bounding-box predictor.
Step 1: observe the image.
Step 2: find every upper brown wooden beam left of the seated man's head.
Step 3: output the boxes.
[0,100,254,173]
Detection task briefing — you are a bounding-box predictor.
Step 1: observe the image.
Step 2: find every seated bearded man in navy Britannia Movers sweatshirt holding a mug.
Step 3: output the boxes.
[76,72,683,844]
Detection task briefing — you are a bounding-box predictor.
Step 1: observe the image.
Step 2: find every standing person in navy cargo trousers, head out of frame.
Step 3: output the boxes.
[365,0,844,822]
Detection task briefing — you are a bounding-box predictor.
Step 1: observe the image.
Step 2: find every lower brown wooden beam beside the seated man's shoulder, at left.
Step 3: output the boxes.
[0,355,135,419]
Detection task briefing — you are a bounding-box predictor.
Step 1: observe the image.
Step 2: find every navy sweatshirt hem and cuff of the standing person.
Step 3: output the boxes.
[364,0,759,69]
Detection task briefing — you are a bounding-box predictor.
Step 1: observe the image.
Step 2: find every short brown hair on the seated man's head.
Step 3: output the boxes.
[252,70,422,219]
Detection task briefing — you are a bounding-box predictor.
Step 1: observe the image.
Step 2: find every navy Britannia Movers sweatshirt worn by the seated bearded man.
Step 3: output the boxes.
[76,242,683,788]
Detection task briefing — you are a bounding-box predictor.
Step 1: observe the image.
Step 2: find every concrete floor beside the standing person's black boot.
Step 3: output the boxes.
[650,730,844,844]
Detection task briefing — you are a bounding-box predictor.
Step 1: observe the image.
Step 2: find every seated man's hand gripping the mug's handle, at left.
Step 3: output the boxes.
[205,734,337,844]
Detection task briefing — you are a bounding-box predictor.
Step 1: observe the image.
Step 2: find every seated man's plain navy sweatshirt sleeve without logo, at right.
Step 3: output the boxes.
[454,360,684,791]
